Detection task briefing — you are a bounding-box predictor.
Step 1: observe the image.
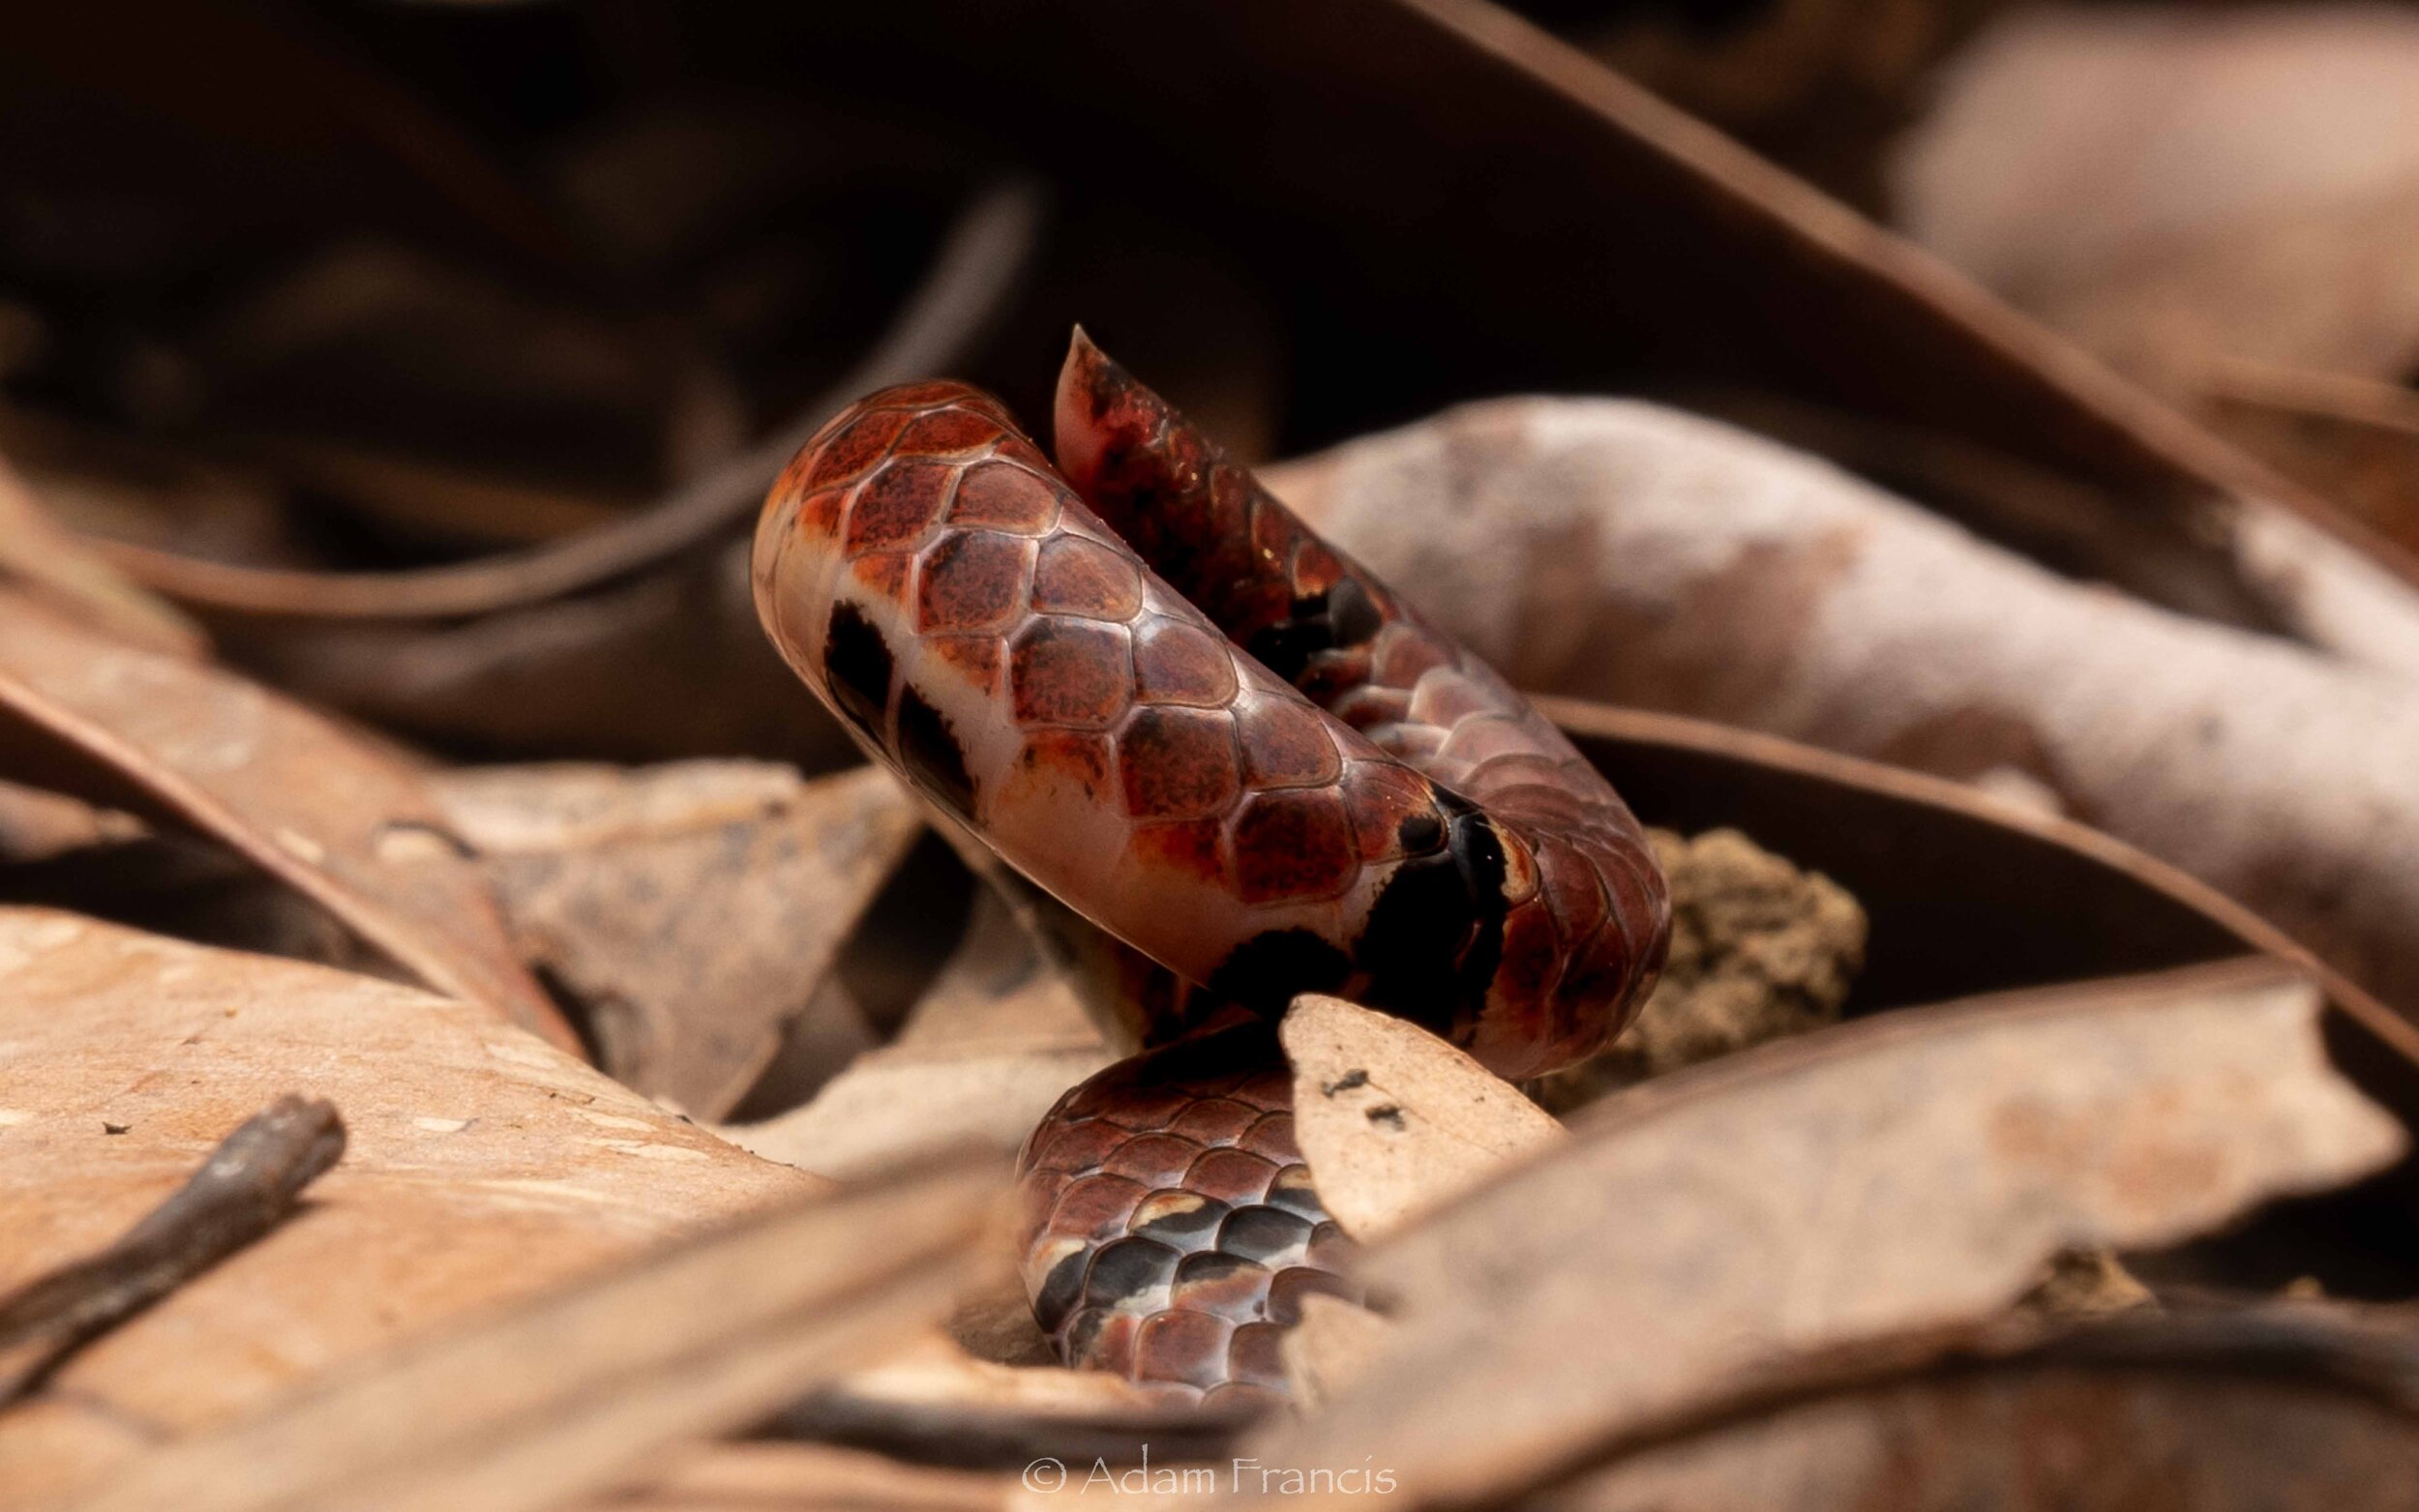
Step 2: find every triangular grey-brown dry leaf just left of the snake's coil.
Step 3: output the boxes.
[431,762,922,1117]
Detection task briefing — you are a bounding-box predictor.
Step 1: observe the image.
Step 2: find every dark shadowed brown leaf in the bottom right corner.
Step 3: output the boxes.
[1512,1309,2419,1512]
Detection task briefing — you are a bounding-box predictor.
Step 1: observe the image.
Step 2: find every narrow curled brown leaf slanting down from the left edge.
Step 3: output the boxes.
[0,593,579,1048]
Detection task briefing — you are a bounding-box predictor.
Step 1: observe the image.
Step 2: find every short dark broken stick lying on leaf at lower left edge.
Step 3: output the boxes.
[0,1093,343,1408]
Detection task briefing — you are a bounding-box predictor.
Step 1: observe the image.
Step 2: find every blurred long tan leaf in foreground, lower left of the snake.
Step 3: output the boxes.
[58,1159,1000,1512]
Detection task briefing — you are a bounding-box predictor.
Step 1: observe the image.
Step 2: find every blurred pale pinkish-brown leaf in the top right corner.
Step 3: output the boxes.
[1895,5,2419,392]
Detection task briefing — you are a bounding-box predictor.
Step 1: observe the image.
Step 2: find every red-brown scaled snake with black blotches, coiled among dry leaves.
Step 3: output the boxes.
[750,329,1672,1408]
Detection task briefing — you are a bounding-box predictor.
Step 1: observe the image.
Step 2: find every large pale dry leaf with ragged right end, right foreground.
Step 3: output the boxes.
[1253,961,2407,1504]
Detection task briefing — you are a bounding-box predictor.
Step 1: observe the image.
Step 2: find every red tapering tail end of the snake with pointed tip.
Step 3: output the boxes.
[1058,332,1669,1072]
